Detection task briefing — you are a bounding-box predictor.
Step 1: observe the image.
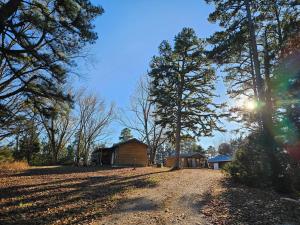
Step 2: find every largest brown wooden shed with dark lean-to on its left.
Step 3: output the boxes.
[92,138,148,166]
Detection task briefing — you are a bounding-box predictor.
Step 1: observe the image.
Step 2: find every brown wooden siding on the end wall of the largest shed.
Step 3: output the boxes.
[114,143,148,166]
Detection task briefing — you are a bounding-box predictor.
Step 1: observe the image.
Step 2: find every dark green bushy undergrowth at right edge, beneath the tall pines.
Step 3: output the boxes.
[224,133,300,193]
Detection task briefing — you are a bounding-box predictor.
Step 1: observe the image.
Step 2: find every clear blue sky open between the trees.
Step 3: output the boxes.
[75,0,239,147]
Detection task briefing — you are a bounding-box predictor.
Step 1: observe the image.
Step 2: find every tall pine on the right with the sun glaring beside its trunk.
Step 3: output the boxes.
[206,0,299,185]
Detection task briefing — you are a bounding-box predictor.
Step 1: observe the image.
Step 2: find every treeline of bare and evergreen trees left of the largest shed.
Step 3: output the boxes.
[2,90,114,165]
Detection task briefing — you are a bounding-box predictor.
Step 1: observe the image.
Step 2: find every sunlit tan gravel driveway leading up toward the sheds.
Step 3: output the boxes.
[101,169,223,225]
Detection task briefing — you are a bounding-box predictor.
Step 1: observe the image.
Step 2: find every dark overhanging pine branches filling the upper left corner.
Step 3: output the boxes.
[0,0,103,136]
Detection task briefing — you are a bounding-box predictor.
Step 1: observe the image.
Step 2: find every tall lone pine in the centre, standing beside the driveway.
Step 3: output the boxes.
[149,28,223,169]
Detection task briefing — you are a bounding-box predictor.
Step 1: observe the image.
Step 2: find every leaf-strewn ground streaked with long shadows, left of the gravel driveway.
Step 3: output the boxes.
[0,168,166,225]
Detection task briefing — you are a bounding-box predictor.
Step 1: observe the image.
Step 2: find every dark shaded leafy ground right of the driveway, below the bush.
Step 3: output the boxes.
[195,178,300,225]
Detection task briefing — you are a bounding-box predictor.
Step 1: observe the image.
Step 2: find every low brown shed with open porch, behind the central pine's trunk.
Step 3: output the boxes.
[165,153,206,168]
